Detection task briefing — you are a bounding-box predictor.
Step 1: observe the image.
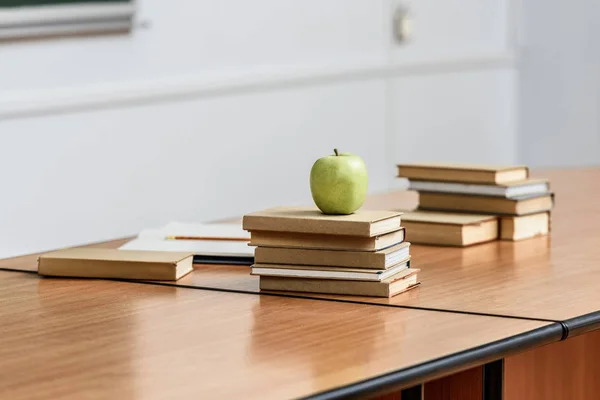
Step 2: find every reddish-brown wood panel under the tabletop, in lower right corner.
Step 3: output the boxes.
[504,330,600,400]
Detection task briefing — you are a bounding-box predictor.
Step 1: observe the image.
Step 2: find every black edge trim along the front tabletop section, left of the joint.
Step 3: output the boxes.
[304,322,562,400]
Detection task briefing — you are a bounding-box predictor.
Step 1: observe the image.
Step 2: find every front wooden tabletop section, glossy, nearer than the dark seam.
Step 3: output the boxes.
[0,272,546,400]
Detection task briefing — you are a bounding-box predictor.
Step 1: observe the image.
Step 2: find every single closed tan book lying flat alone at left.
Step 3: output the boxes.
[38,248,193,281]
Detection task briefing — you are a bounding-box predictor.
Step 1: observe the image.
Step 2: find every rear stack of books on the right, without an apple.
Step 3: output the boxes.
[398,163,554,246]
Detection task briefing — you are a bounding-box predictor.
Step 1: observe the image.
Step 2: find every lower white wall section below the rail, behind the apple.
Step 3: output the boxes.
[0,81,385,258]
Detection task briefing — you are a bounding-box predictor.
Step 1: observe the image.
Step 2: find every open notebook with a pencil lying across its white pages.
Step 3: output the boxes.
[120,222,254,265]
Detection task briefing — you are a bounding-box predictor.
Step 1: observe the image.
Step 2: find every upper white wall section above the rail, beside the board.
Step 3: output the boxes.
[0,0,387,91]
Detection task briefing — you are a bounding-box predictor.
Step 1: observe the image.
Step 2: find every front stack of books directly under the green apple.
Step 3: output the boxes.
[243,207,419,297]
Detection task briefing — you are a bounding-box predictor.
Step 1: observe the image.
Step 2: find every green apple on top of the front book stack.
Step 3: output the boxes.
[310,149,369,215]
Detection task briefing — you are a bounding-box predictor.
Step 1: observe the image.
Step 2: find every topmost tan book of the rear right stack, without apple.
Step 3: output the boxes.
[398,163,529,185]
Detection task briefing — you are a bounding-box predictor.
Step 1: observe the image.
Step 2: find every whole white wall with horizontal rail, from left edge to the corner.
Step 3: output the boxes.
[0,0,517,256]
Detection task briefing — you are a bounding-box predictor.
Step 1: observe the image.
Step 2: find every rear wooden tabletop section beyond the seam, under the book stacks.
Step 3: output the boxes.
[0,168,600,329]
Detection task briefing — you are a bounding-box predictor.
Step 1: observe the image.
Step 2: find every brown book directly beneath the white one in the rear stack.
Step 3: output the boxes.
[419,192,554,215]
